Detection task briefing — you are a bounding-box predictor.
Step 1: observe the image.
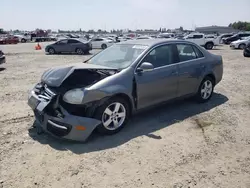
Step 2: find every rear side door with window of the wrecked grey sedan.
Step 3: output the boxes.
[176,43,205,97]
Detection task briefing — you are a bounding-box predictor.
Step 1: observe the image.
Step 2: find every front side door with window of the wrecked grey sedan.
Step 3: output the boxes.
[135,44,178,109]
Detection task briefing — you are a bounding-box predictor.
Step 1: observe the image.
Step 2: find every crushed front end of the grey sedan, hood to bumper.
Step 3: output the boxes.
[28,65,120,141]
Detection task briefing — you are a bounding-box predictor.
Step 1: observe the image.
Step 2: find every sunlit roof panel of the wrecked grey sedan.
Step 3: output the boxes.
[120,38,183,46]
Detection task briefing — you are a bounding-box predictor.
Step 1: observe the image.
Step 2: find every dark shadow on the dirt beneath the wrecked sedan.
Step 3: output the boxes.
[29,93,228,154]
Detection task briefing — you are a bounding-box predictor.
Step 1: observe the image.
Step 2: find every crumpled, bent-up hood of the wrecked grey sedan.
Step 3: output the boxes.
[41,63,116,87]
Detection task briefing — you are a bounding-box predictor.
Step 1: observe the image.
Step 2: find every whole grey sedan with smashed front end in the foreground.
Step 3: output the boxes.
[28,39,223,141]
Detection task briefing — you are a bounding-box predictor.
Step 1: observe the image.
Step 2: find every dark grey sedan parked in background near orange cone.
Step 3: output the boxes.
[45,39,92,55]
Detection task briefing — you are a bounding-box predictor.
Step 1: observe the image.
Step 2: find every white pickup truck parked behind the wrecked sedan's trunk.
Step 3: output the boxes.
[184,33,220,50]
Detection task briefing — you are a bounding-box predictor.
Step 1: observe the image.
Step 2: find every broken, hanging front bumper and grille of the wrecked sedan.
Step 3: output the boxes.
[28,84,101,141]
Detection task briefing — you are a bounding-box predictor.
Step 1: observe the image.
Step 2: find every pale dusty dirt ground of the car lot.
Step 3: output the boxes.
[0,43,250,188]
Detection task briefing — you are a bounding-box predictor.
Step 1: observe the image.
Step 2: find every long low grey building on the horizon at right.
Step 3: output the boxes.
[195,25,239,34]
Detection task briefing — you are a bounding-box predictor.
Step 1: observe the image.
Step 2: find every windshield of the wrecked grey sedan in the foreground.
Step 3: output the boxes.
[88,44,148,69]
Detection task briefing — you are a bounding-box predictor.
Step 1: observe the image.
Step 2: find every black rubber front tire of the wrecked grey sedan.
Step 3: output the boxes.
[94,97,131,135]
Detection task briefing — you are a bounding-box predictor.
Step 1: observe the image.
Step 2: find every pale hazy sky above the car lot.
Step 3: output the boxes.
[0,0,250,31]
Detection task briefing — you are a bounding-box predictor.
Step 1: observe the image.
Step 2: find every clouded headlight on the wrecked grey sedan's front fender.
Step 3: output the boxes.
[63,89,84,104]
